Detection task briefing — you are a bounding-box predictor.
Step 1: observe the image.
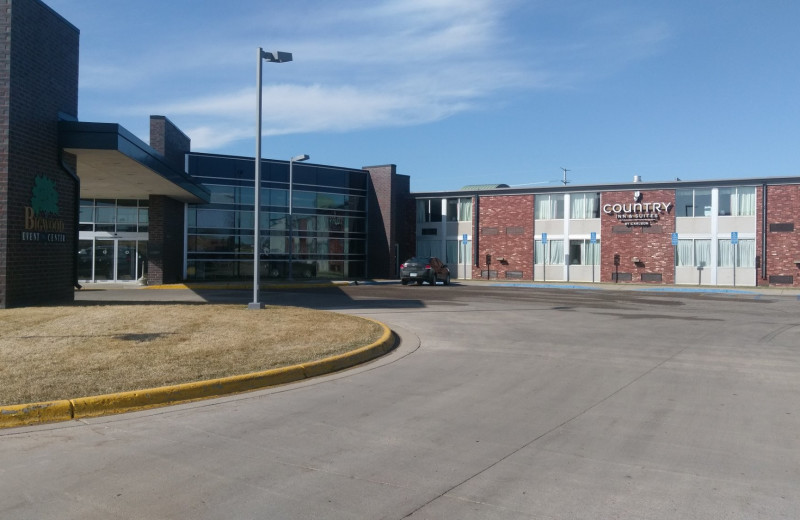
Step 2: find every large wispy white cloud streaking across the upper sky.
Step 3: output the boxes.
[69,0,668,150]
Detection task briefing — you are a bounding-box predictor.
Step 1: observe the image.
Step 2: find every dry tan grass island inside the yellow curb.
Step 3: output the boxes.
[0,304,383,405]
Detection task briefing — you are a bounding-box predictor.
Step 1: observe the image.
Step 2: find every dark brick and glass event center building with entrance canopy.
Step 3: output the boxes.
[0,0,414,308]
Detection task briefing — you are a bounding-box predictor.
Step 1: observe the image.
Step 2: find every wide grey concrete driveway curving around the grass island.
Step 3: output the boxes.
[0,284,800,520]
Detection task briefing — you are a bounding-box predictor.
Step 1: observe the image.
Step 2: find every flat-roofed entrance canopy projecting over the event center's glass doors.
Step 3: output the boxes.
[59,121,209,203]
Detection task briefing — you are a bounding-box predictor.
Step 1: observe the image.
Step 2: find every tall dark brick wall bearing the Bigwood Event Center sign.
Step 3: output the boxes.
[0,0,79,307]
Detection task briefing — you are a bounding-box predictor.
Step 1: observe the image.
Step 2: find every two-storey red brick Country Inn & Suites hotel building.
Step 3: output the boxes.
[413,177,800,287]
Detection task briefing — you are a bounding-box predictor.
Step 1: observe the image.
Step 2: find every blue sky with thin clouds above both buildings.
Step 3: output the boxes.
[45,0,800,191]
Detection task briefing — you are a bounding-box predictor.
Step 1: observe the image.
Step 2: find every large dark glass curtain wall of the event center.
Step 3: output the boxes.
[186,154,367,280]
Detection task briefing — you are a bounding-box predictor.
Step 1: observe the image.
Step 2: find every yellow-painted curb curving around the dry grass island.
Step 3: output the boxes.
[0,318,397,428]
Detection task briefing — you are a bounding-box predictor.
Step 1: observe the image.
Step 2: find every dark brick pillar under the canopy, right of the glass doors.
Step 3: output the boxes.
[147,195,184,285]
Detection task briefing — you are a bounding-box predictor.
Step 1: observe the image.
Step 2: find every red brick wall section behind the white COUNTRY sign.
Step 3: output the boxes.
[600,190,675,284]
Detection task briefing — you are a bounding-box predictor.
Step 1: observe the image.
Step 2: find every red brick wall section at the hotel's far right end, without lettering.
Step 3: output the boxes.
[756,185,800,287]
